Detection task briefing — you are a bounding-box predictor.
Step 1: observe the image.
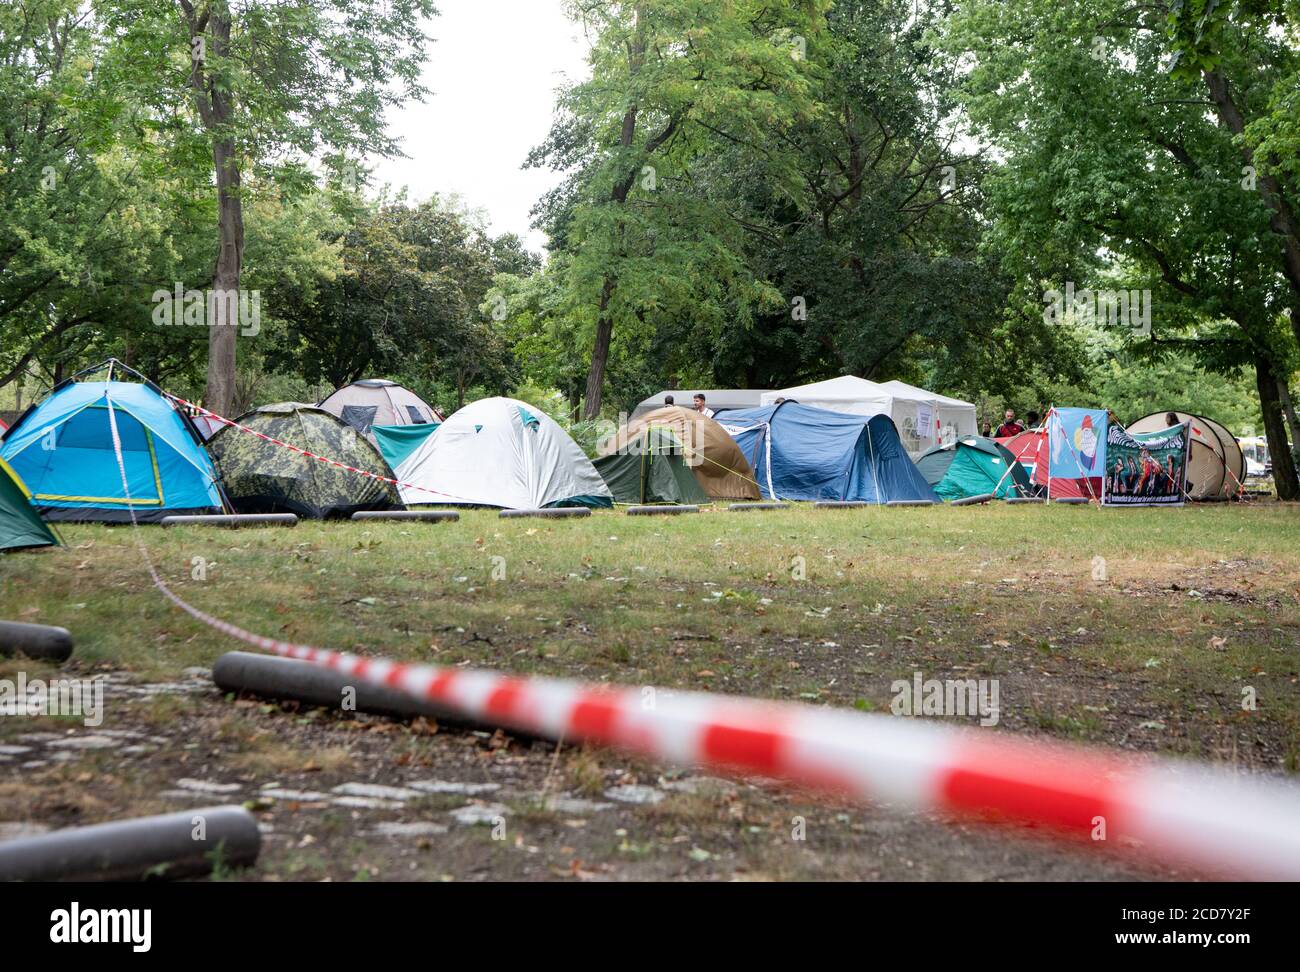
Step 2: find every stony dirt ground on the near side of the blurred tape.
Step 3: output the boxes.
[0,669,1170,881]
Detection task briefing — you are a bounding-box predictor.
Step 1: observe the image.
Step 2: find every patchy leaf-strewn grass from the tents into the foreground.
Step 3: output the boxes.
[0,503,1300,877]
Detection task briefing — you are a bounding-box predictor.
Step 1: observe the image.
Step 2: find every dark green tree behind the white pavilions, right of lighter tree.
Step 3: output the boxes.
[711,0,1079,395]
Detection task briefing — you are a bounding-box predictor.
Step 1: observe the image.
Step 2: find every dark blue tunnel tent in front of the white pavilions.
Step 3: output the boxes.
[720,402,940,503]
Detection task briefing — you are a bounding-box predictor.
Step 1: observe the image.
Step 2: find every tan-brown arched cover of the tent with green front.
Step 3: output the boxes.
[599,405,759,499]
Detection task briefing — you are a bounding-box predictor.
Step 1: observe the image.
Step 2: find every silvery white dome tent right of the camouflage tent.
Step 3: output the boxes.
[394,398,614,509]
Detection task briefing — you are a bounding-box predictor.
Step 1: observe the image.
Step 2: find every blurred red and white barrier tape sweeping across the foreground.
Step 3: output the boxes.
[108,389,1300,880]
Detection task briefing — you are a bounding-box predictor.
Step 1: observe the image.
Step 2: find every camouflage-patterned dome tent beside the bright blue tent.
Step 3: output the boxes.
[208,402,402,520]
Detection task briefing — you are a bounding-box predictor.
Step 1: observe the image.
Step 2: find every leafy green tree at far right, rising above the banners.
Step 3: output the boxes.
[943,0,1300,498]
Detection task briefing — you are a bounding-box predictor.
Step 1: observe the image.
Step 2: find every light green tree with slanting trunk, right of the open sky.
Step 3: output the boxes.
[530,0,827,417]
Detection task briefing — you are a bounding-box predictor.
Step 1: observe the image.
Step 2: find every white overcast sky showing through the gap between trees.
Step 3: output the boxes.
[374,0,586,251]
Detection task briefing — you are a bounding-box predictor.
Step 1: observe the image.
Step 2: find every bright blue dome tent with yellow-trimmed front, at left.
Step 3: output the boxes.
[0,361,224,522]
